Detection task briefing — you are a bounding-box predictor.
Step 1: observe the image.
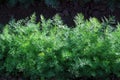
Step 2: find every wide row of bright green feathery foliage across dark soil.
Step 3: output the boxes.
[0,14,120,80]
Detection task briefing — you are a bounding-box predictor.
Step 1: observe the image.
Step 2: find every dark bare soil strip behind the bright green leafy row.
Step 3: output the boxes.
[0,2,120,26]
